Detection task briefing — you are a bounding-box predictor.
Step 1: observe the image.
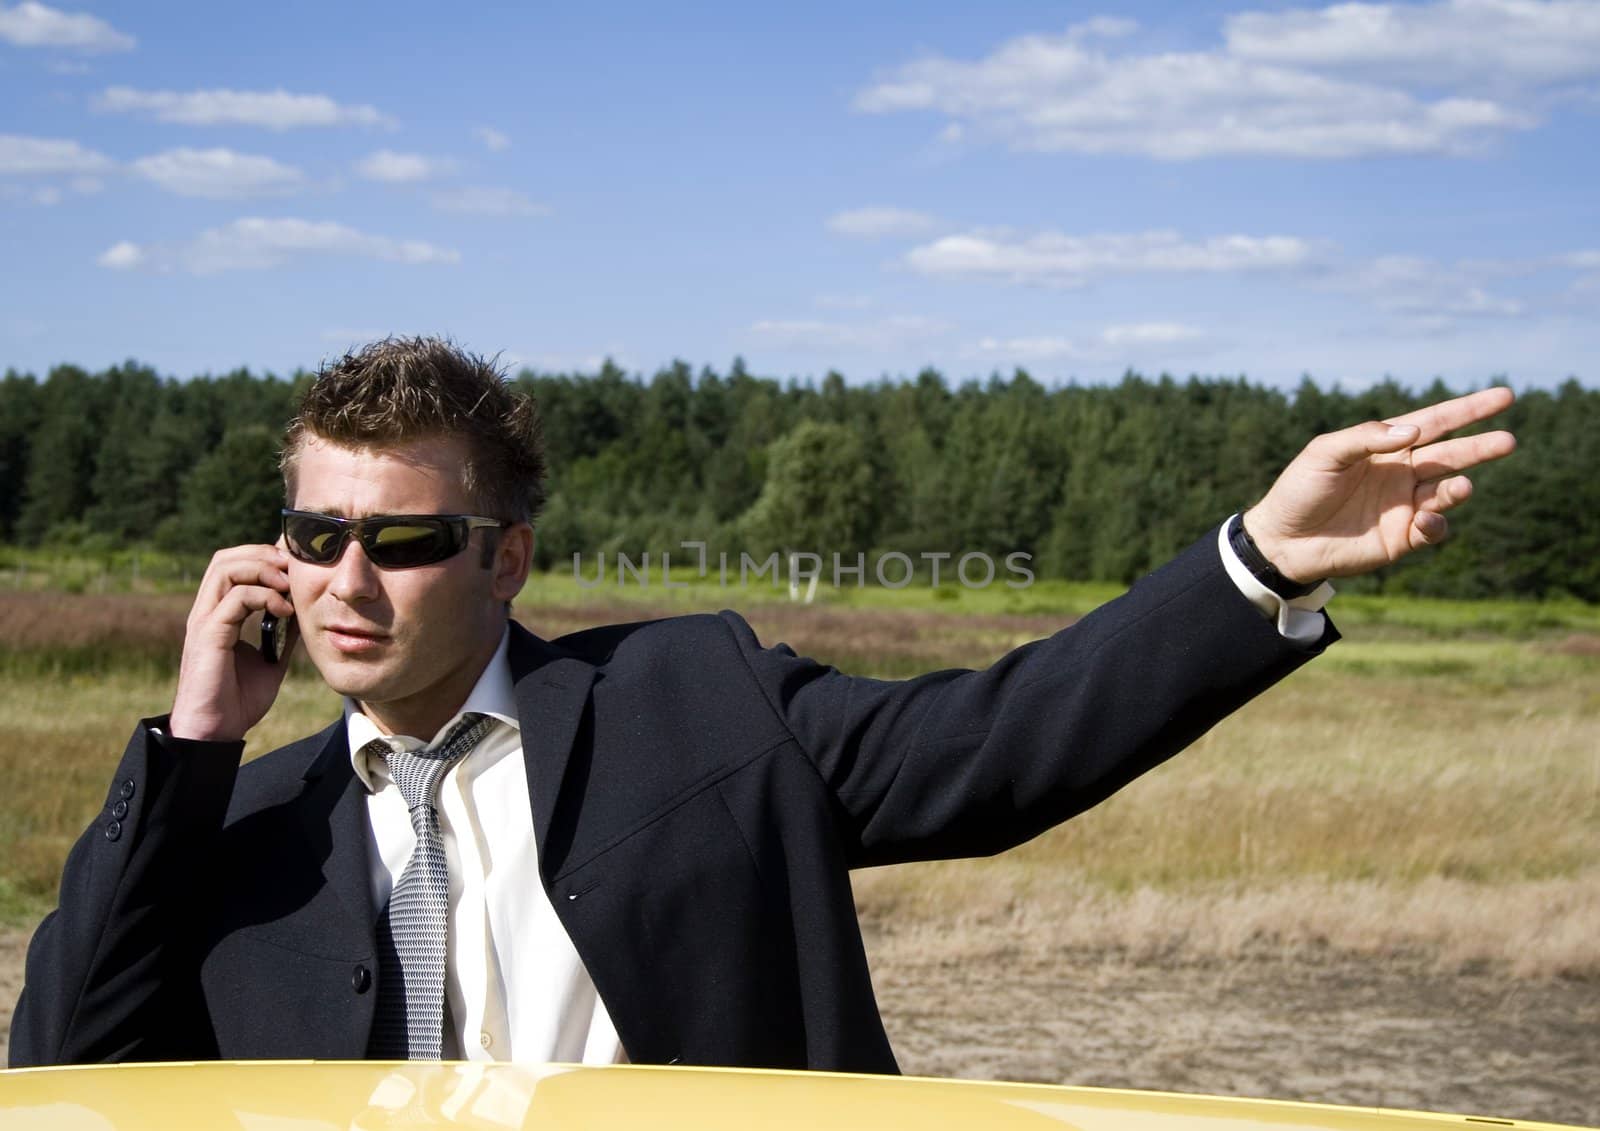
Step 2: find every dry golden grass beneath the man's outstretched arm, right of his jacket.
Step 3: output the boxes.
[856,640,1600,977]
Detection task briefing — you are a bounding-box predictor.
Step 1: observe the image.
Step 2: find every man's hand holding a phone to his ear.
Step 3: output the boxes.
[168,546,294,741]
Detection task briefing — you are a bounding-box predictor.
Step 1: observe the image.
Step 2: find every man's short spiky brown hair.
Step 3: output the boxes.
[278,338,544,522]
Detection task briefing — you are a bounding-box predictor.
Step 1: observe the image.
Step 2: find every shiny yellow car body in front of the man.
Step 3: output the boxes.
[0,1061,1593,1131]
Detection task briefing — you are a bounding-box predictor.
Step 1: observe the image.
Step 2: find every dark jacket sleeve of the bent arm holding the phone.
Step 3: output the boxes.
[10,718,245,1067]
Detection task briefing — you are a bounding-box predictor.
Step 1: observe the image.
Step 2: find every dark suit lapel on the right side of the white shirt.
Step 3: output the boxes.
[510,624,595,883]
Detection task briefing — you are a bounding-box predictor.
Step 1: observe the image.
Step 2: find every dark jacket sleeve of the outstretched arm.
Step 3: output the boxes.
[741,530,1338,865]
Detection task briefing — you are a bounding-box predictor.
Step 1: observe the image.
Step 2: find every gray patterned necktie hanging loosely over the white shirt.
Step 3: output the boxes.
[368,713,494,1061]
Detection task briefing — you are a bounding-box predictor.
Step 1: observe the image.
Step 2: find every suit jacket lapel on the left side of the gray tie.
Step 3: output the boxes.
[298,720,378,947]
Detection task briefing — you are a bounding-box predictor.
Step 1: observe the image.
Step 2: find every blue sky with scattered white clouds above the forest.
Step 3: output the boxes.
[0,0,1600,387]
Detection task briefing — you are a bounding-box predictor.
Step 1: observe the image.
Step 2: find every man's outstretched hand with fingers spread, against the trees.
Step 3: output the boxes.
[1245,389,1517,581]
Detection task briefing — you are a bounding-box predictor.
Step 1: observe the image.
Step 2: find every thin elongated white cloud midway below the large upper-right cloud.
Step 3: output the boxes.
[906,232,1314,286]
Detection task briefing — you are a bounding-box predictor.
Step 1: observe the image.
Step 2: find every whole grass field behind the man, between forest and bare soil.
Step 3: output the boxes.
[0,576,1600,976]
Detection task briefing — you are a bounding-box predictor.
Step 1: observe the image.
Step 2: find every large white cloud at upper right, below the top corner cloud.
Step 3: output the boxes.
[856,9,1555,160]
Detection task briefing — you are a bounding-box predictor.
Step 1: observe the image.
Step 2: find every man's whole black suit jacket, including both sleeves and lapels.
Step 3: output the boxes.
[10,533,1336,1072]
